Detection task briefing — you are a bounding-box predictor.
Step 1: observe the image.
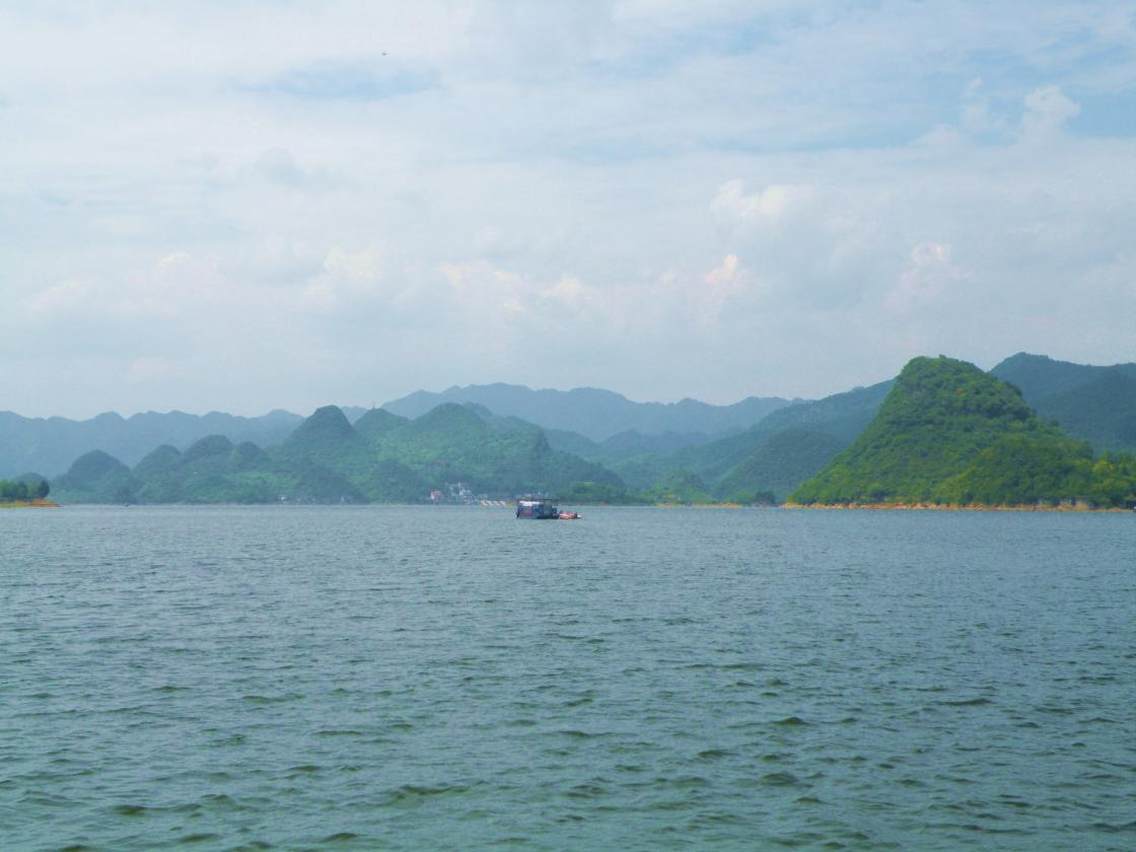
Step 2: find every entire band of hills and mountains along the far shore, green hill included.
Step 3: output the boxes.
[35,353,1136,506]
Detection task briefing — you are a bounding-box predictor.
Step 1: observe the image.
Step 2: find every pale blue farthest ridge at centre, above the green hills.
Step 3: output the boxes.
[383,384,791,441]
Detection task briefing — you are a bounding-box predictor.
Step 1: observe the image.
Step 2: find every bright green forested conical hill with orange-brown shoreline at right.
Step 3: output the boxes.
[791,357,1136,506]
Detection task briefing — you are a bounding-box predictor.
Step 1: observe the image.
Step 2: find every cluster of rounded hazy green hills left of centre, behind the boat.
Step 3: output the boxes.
[52,403,630,503]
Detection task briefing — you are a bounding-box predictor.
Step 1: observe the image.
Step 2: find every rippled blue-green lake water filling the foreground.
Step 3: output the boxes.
[0,507,1136,850]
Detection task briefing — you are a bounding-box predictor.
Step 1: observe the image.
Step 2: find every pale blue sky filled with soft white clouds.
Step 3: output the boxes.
[0,0,1136,417]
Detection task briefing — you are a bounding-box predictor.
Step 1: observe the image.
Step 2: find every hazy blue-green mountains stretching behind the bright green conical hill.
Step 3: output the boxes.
[11,353,1136,502]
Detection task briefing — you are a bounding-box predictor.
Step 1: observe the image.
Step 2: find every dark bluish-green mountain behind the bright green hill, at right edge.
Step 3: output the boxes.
[991,352,1136,452]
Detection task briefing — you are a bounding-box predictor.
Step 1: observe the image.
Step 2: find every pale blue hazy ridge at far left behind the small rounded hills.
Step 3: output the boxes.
[0,411,303,477]
